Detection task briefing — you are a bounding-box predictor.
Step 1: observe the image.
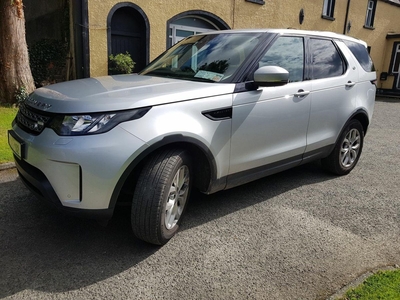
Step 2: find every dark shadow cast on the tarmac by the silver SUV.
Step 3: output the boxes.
[0,164,335,298]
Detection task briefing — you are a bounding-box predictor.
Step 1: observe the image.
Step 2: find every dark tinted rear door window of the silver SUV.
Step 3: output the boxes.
[310,39,346,79]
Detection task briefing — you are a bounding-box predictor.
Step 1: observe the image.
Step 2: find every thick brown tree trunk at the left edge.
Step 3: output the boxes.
[0,0,35,104]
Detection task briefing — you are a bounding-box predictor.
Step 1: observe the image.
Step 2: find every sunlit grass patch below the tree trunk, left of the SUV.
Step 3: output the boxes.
[0,106,18,164]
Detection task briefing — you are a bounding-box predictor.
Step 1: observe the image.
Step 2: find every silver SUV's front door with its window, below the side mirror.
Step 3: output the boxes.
[228,36,311,186]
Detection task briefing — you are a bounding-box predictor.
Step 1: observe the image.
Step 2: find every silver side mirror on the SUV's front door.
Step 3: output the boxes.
[254,66,289,86]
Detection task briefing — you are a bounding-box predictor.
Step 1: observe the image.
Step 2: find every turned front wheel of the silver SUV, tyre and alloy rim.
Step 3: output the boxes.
[131,149,192,245]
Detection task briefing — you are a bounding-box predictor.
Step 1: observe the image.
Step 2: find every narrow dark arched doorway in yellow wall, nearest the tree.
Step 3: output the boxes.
[107,3,150,72]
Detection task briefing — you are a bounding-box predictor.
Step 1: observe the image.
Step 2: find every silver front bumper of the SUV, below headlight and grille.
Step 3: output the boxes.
[13,125,146,218]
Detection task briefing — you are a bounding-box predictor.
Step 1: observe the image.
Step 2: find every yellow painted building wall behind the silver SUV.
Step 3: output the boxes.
[88,0,400,88]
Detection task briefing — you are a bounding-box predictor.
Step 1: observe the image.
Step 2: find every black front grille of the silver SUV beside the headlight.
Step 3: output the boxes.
[15,104,50,135]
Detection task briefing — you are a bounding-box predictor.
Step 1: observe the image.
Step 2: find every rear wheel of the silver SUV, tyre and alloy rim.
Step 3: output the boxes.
[322,120,364,175]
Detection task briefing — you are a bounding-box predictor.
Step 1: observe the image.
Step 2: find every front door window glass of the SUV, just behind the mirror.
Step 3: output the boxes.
[259,36,304,82]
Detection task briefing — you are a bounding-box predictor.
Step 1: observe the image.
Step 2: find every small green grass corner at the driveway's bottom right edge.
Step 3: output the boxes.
[341,270,400,300]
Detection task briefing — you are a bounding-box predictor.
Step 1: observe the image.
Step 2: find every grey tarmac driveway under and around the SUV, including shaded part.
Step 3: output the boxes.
[0,99,400,299]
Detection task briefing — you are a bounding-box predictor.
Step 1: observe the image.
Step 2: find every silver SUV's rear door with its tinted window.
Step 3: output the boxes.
[306,38,358,155]
